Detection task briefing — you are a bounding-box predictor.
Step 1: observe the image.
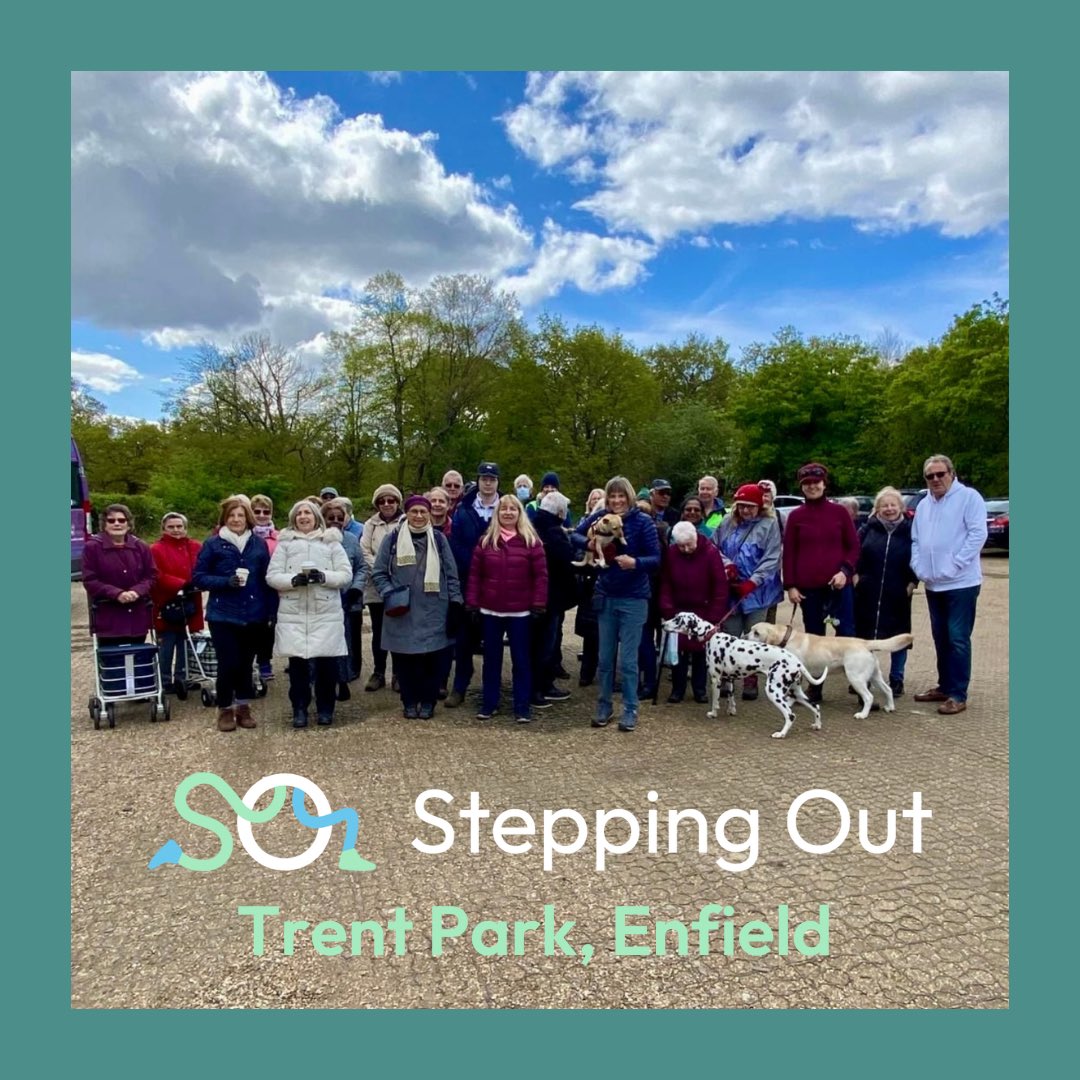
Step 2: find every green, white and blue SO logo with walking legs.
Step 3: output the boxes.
[148,772,375,873]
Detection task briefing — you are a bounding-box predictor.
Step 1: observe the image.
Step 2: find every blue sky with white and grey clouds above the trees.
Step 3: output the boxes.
[71,71,1009,420]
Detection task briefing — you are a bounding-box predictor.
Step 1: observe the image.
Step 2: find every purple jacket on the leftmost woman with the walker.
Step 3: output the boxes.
[82,532,157,637]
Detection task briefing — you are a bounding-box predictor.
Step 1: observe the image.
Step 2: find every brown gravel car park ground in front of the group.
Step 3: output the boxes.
[71,556,1009,1009]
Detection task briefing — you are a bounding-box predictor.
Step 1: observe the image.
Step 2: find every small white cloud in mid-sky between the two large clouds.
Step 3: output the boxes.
[500,218,656,305]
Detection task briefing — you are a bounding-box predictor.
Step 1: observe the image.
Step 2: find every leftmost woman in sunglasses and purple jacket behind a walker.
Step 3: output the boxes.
[82,502,154,645]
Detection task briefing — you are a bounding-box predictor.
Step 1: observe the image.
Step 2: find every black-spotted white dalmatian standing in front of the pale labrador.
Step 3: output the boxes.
[661,611,826,739]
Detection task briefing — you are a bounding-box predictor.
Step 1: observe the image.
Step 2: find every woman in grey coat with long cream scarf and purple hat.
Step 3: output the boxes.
[372,495,462,720]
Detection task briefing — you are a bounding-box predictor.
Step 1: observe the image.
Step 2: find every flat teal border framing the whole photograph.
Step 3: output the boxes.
[14,0,1062,1077]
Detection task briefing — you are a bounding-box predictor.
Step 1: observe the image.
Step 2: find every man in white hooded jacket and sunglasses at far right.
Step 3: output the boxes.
[912,454,986,716]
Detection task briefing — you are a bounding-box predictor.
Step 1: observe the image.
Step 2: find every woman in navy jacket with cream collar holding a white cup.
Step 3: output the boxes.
[193,496,271,731]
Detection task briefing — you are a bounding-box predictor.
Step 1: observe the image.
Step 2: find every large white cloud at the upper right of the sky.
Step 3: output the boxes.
[503,71,1009,242]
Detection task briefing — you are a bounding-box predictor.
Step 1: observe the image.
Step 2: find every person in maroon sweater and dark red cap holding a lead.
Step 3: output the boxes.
[784,461,859,702]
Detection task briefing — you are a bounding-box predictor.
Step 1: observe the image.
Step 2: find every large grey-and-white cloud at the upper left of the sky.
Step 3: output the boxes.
[71,72,532,336]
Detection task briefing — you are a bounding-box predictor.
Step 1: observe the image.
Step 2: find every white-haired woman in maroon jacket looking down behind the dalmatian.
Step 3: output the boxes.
[660,522,728,705]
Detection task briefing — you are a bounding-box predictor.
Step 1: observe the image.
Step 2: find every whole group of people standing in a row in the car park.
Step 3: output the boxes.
[83,455,986,731]
